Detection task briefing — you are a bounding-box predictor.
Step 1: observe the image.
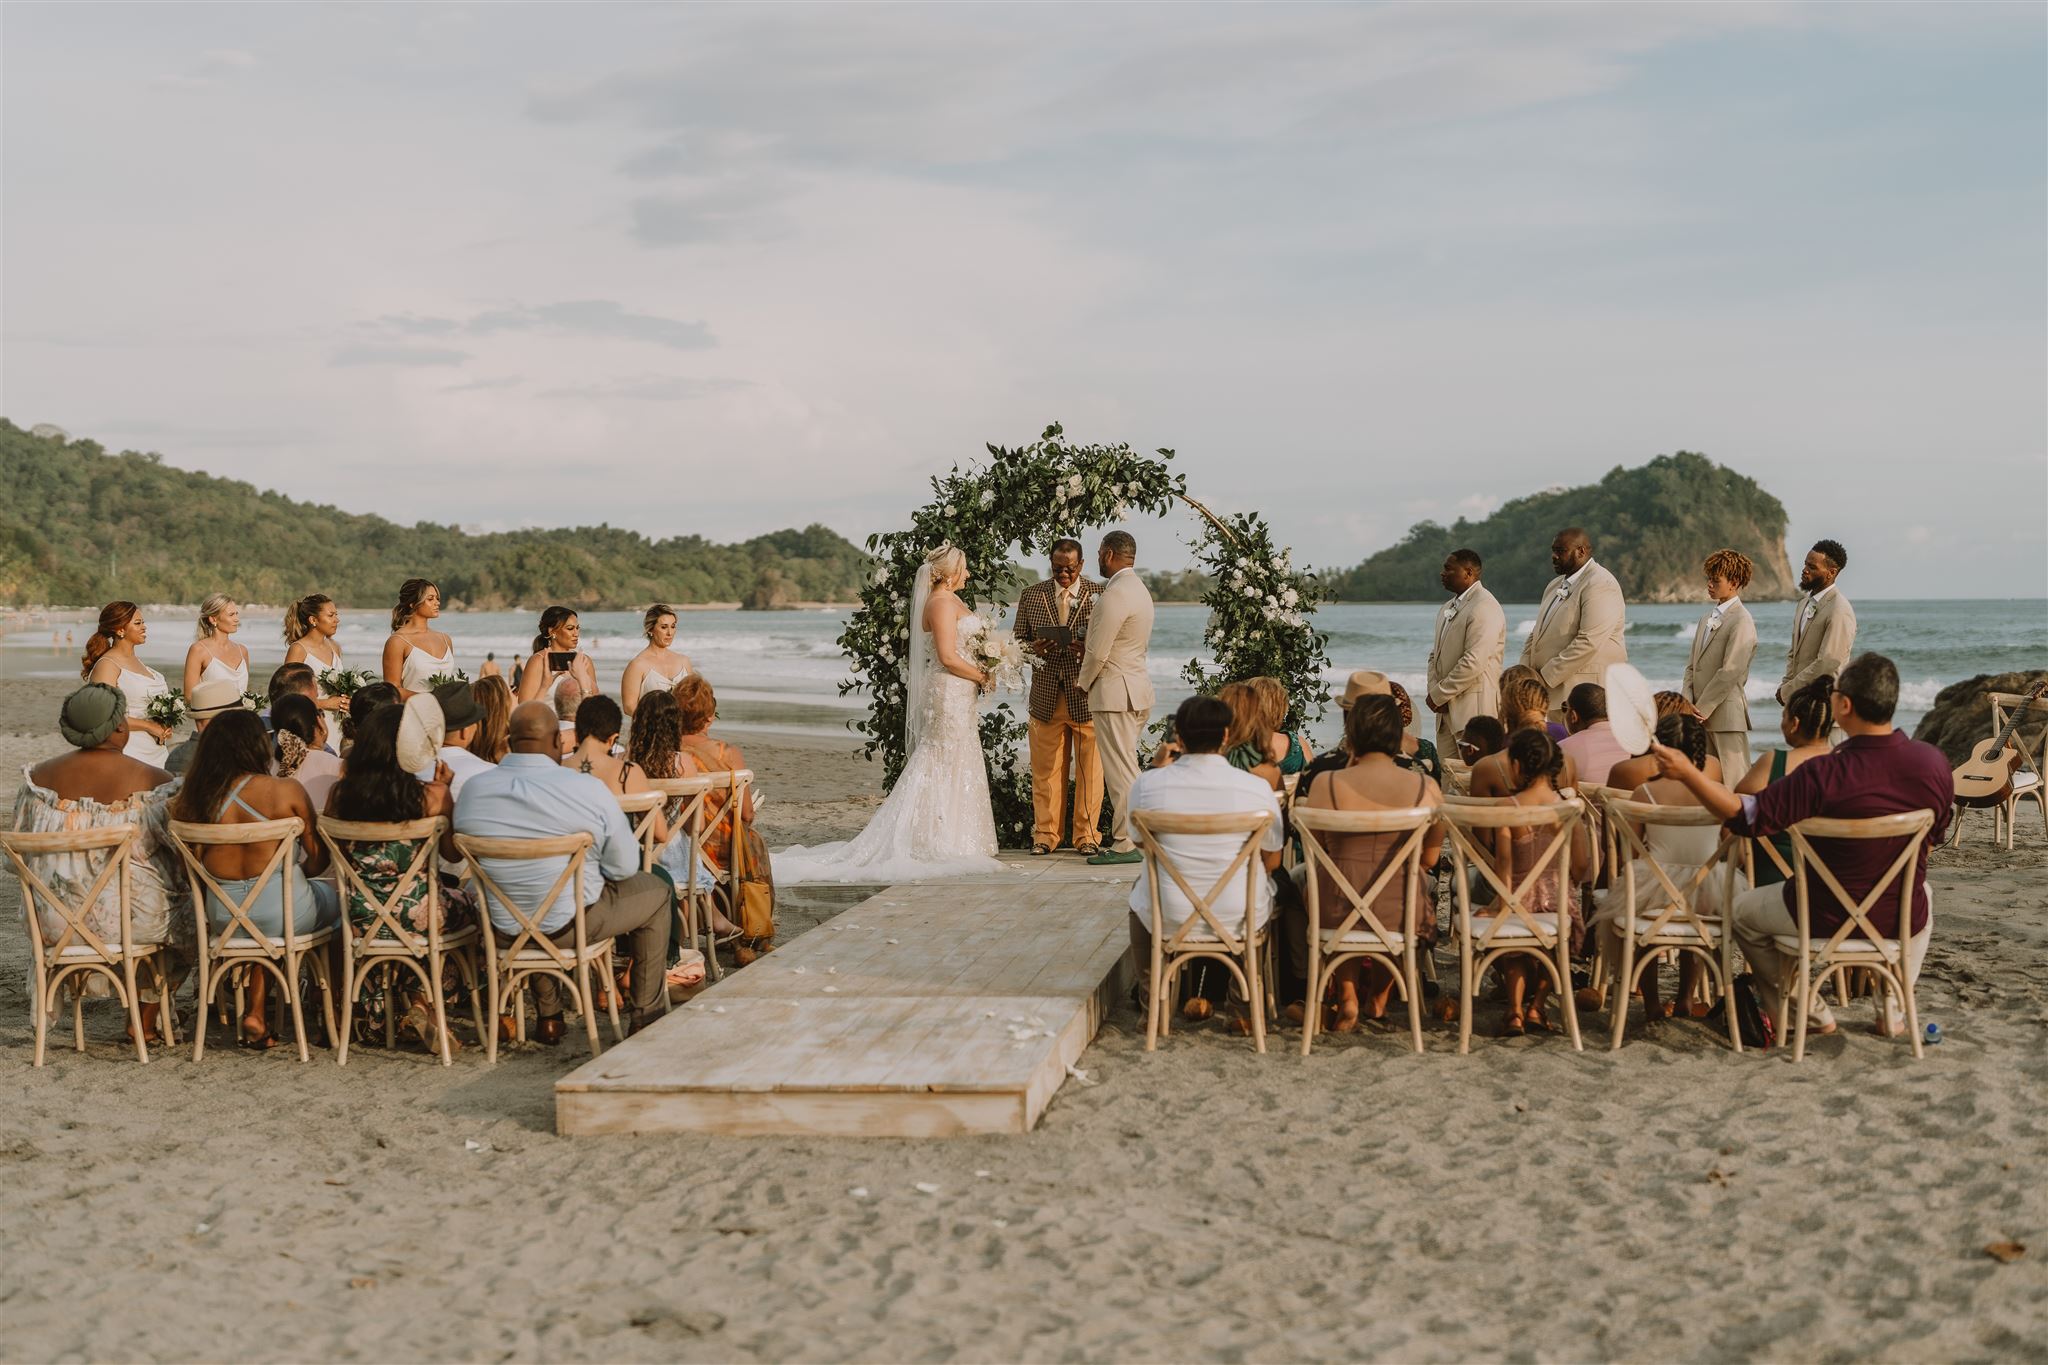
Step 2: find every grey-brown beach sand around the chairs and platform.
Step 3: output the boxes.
[0,681,2048,1361]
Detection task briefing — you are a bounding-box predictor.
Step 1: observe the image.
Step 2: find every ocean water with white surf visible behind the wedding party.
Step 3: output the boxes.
[0,598,2048,747]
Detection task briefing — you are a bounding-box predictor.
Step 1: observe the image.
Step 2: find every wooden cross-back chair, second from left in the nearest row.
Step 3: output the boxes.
[170,814,336,1062]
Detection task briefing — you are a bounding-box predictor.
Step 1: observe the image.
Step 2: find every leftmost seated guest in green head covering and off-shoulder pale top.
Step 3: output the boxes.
[12,684,187,1040]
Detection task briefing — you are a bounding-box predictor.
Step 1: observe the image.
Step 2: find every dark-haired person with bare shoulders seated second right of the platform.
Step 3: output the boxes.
[1300,696,1444,1033]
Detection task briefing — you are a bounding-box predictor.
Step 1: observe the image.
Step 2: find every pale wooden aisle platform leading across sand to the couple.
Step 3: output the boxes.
[555,853,1130,1138]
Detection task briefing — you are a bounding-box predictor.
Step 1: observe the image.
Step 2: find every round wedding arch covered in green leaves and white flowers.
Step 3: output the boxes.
[840,422,1329,847]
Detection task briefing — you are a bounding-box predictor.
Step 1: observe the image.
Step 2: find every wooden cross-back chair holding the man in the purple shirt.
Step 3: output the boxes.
[1774,810,1933,1062]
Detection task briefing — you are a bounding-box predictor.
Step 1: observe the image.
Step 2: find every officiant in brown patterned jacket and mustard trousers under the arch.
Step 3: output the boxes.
[1016,540,1102,857]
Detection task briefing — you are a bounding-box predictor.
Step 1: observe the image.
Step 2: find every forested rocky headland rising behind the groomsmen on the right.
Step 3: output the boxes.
[1331,450,1798,602]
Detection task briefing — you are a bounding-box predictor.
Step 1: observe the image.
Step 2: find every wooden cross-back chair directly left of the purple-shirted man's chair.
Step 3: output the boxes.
[1606,794,1744,1052]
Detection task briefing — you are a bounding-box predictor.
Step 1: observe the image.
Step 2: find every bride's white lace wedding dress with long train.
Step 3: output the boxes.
[772,612,1004,886]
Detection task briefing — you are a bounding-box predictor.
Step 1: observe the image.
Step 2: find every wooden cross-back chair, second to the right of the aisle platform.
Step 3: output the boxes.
[1294,806,1436,1056]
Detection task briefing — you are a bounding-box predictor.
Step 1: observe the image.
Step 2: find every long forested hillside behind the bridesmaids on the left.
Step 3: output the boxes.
[0,417,868,610]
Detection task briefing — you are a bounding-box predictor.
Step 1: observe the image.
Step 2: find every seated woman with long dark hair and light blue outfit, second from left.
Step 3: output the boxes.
[170,710,340,1050]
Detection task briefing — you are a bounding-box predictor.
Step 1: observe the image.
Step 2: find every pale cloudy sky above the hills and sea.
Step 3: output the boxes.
[0,4,2048,598]
